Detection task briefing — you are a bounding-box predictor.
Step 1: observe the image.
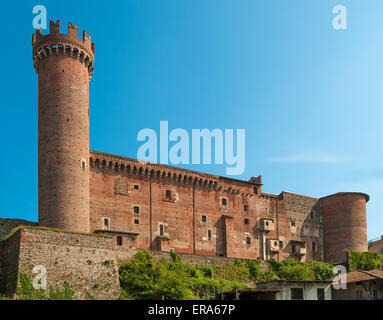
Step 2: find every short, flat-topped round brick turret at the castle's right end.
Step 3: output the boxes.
[321,192,369,262]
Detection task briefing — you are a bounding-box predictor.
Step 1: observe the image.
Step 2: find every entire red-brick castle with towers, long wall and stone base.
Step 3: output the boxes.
[0,21,369,297]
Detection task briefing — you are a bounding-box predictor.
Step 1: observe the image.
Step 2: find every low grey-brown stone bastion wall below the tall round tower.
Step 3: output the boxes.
[2,228,119,299]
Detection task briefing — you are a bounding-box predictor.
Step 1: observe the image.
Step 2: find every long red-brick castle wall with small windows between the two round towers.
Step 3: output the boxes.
[90,151,323,261]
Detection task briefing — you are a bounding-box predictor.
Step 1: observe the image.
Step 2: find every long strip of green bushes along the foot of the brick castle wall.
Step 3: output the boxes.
[119,251,334,300]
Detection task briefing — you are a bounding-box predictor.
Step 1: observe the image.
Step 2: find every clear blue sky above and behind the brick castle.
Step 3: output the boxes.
[0,0,383,239]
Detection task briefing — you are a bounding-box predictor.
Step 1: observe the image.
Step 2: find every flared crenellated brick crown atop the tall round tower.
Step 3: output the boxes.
[32,20,95,79]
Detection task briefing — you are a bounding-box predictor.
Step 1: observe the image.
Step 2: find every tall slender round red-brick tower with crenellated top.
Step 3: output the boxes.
[32,21,94,232]
